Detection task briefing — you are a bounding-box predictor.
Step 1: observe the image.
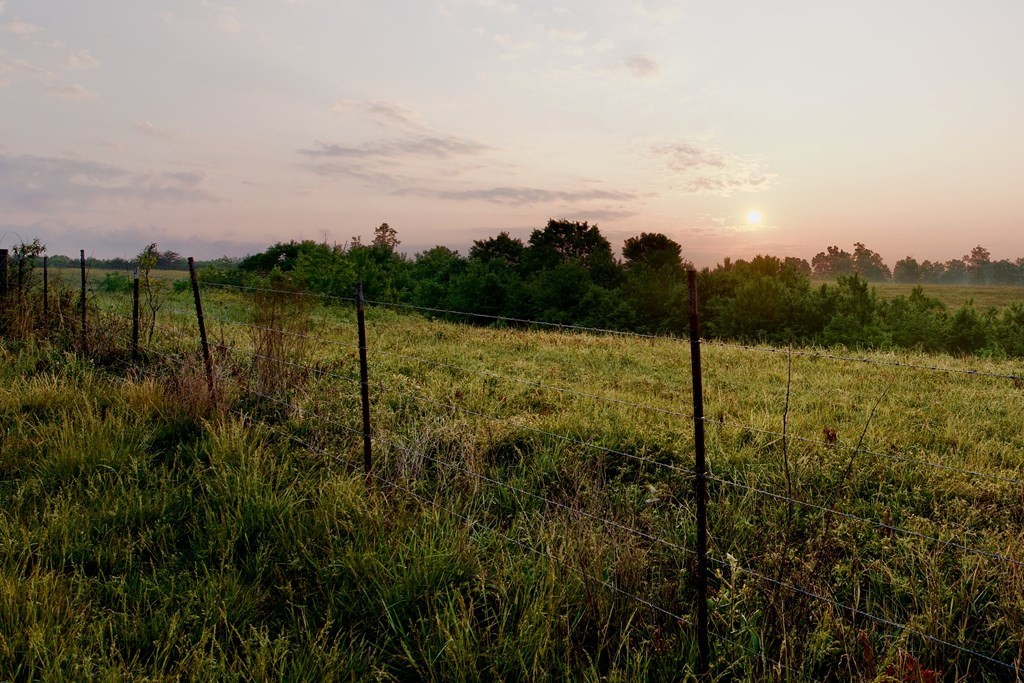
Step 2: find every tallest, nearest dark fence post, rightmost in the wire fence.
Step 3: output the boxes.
[686,270,711,681]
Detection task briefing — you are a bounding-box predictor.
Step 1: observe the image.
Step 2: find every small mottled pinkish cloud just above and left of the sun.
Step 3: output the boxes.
[651,142,778,197]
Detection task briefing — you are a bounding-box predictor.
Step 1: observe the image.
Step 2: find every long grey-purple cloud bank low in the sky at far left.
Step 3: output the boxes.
[0,155,216,211]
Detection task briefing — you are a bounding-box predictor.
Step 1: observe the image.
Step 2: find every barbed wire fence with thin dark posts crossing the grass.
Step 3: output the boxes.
[6,251,1024,681]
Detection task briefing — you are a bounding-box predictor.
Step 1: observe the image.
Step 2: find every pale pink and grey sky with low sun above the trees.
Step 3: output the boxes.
[0,0,1024,265]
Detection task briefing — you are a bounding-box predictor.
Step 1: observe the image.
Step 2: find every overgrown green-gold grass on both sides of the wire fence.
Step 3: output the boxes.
[0,286,1024,681]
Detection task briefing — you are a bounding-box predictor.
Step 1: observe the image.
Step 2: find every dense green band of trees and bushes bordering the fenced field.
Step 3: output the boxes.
[201,220,1024,356]
